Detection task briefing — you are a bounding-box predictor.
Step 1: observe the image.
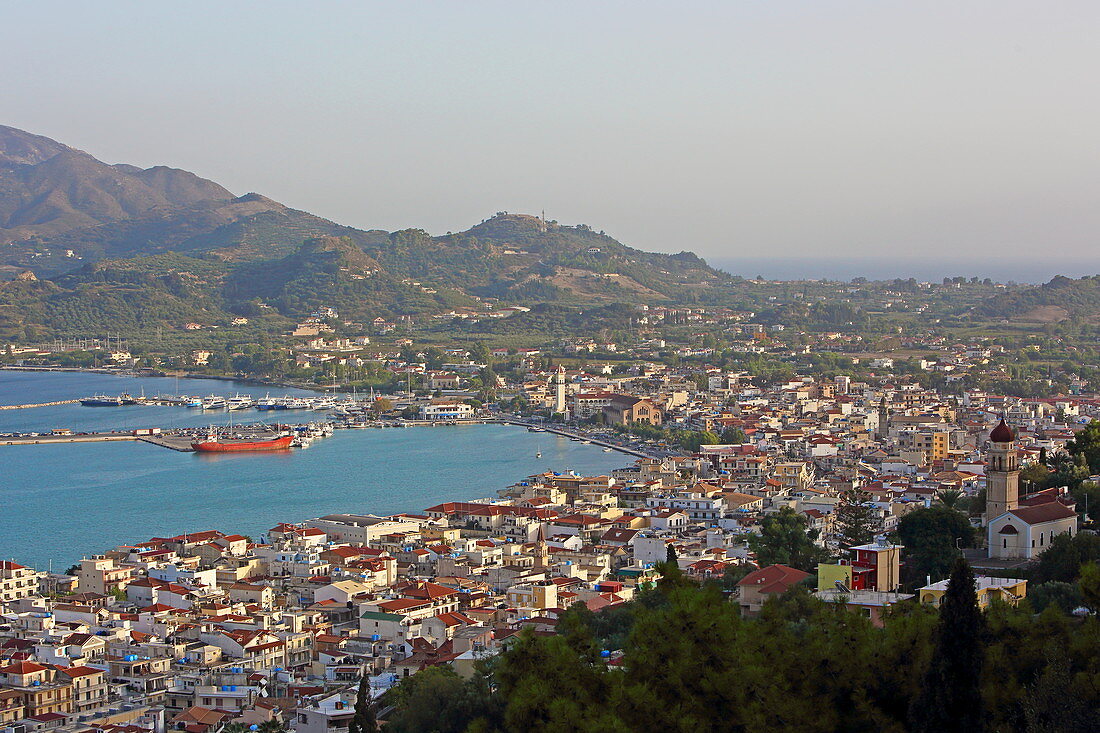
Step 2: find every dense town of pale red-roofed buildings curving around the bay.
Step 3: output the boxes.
[0,354,1100,733]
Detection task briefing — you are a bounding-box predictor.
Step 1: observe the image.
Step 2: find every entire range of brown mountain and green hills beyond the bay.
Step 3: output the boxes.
[0,127,737,338]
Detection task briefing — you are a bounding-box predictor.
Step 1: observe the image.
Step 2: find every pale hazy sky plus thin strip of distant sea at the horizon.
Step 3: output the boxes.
[0,0,1100,276]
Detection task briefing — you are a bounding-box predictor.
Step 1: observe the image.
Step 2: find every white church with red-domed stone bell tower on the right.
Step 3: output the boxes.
[982,418,1077,560]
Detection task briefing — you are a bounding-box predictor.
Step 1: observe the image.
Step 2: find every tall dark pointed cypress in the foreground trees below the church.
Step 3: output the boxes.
[910,558,985,733]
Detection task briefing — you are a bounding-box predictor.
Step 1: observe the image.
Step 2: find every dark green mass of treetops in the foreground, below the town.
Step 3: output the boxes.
[385,564,1100,733]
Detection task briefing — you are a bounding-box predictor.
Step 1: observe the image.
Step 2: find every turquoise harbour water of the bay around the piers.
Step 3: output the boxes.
[0,370,634,571]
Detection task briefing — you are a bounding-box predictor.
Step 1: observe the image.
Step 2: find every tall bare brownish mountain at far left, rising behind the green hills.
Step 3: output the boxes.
[0,125,360,275]
